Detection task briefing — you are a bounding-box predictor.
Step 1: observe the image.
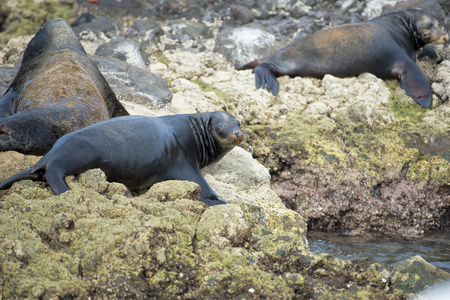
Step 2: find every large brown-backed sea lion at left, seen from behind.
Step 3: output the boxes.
[0,19,128,155]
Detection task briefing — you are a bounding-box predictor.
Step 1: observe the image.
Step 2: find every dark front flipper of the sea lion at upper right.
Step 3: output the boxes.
[392,61,433,108]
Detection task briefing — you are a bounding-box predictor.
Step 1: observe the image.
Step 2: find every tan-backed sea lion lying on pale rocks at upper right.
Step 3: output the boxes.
[236,9,448,108]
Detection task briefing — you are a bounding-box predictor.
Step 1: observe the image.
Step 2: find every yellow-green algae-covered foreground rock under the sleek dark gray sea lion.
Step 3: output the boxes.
[0,148,428,299]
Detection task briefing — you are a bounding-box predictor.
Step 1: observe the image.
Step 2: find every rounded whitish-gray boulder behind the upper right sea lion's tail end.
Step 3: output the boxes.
[215,23,283,65]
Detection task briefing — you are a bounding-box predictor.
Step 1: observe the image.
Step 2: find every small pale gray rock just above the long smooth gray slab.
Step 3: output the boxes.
[95,36,148,69]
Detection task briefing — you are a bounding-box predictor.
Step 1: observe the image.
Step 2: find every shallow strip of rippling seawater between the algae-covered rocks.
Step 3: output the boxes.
[308,230,450,273]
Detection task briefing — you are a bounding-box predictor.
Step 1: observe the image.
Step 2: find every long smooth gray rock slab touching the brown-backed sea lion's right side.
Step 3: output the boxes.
[91,56,172,107]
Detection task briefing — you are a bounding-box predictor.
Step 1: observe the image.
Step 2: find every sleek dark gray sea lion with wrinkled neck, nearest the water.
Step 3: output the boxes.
[0,112,243,205]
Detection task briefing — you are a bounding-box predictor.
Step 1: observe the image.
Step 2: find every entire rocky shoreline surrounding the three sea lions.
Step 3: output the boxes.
[0,0,450,299]
